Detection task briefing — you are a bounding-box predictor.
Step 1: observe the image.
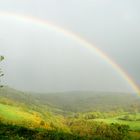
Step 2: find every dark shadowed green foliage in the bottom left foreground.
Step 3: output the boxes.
[0,123,86,140]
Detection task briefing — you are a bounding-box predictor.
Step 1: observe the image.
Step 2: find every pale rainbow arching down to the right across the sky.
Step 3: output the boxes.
[0,12,140,95]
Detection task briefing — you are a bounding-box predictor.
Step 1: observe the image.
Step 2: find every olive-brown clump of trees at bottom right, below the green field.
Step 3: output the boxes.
[68,120,130,140]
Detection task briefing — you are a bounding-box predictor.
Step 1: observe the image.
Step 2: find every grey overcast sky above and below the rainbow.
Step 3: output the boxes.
[0,0,140,92]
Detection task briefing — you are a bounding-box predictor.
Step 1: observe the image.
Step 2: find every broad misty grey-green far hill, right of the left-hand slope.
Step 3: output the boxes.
[32,91,140,112]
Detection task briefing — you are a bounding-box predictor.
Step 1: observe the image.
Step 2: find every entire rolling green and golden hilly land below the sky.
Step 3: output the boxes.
[0,87,140,140]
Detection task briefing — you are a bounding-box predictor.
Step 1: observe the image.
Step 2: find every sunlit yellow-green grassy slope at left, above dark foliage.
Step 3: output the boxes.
[0,103,69,131]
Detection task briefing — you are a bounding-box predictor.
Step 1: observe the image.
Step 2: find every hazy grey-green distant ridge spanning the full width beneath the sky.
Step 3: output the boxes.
[0,86,140,112]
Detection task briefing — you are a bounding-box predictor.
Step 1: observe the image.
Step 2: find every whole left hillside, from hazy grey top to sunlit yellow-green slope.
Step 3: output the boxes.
[0,87,69,130]
